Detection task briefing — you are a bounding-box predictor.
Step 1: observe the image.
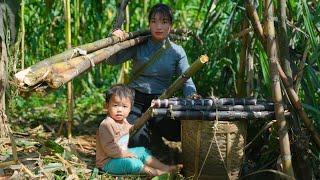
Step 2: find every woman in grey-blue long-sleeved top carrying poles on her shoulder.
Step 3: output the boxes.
[107,3,196,148]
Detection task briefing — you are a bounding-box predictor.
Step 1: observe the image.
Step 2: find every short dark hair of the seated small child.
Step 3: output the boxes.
[106,84,135,106]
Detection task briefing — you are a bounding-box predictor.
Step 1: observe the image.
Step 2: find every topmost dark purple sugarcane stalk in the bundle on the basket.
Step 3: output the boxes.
[151,98,273,107]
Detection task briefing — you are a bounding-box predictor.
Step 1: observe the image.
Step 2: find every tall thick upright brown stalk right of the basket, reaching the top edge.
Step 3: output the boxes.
[264,0,294,177]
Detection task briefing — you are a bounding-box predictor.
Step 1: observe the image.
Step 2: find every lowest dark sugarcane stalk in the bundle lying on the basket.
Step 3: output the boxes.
[151,108,290,121]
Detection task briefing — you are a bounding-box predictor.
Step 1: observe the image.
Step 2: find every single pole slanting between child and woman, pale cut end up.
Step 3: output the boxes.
[130,55,209,136]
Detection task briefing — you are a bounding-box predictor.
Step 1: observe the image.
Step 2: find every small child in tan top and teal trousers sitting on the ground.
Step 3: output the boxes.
[96,85,182,176]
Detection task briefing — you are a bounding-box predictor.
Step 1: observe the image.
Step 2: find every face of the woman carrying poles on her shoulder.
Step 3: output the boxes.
[149,13,171,42]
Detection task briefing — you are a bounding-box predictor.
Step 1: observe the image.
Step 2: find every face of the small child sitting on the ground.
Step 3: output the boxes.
[106,95,131,121]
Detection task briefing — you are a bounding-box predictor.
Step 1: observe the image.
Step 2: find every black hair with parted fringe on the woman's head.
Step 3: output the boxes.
[148,3,173,24]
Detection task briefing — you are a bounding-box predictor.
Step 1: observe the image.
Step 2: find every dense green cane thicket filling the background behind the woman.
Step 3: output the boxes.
[0,0,320,177]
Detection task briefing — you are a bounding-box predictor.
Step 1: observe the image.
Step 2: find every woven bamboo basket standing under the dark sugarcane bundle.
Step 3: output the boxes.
[181,120,247,180]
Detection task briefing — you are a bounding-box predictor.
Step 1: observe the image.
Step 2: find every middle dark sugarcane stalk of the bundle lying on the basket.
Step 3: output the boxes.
[153,104,274,111]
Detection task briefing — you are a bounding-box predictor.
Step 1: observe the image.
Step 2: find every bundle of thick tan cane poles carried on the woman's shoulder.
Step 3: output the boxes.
[15,30,188,92]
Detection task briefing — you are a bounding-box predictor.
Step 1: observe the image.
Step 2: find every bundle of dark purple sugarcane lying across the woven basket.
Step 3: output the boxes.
[151,98,289,121]
